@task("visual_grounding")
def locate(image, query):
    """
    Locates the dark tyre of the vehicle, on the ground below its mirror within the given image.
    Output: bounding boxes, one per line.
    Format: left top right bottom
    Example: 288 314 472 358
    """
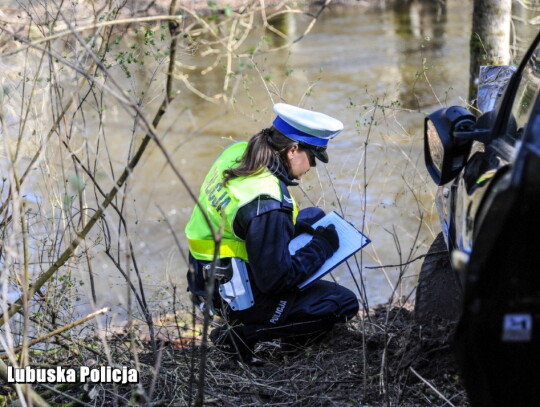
414 232 463 322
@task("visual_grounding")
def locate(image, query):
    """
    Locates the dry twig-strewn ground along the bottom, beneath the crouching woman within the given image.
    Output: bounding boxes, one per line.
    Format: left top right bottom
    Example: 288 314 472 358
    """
6 306 469 407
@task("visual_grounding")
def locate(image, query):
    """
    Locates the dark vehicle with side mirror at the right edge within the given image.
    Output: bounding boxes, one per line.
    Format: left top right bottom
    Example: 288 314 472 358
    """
417 34 540 407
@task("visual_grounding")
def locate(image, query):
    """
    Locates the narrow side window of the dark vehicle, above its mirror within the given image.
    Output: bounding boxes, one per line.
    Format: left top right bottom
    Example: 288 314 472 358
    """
504 46 540 144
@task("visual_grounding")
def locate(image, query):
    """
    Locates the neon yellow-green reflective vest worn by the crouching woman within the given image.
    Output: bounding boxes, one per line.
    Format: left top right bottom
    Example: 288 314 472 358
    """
185 142 298 261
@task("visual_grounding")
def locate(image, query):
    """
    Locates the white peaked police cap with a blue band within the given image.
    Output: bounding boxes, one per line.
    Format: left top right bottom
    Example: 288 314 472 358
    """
273 103 343 148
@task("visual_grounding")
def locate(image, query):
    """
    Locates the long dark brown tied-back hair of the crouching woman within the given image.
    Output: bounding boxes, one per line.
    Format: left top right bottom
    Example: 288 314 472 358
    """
223 126 298 185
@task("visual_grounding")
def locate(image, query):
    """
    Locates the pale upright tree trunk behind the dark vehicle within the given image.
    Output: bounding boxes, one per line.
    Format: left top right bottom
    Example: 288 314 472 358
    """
469 0 512 100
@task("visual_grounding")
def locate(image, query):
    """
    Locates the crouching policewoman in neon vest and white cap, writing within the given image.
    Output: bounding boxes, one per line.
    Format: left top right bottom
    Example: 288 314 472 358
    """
185 103 358 360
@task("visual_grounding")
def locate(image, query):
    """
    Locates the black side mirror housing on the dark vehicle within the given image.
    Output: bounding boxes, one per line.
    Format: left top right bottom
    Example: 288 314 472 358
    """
424 106 476 185
